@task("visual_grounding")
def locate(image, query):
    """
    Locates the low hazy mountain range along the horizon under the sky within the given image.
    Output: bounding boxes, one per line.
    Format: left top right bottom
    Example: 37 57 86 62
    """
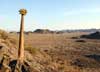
10 29 100 34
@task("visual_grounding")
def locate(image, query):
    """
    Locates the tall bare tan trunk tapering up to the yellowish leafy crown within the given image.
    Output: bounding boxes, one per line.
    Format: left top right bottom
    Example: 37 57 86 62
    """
14 14 24 72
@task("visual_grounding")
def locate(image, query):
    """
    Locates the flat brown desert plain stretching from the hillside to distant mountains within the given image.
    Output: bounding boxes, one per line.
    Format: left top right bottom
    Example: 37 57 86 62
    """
10 32 100 72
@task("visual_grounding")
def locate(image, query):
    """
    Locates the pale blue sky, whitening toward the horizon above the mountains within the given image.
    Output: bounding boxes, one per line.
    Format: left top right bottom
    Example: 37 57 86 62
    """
0 0 100 31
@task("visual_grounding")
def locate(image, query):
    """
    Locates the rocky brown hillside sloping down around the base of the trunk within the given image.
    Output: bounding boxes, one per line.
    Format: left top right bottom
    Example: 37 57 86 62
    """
0 30 50 72
